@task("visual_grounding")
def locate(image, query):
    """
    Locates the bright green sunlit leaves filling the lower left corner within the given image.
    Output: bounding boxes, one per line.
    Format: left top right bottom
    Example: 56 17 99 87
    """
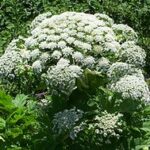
0 91 39 150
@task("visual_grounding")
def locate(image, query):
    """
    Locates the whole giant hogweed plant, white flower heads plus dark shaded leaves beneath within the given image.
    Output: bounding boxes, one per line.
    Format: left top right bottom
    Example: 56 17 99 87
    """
0 12 150 150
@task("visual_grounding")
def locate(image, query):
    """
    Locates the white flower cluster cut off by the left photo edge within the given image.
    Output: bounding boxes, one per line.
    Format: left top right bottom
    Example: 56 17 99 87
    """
0 51 22 78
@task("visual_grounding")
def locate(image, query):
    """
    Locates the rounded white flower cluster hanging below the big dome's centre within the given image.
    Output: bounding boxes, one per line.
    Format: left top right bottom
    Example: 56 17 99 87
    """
46 58 82 95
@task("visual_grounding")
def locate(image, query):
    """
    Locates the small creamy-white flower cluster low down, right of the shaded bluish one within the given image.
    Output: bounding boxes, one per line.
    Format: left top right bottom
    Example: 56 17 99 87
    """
88 112 123 139
